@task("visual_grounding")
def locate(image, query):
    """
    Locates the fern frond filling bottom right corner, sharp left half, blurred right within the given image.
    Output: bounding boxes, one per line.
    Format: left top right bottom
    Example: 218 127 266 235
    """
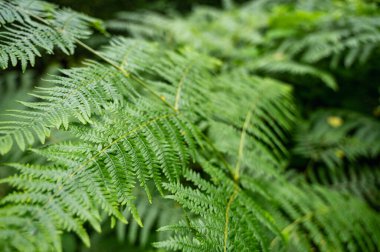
155 160 380 251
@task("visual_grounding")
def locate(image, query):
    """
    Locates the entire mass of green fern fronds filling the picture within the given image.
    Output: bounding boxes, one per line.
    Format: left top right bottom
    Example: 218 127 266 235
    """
0 0 380 251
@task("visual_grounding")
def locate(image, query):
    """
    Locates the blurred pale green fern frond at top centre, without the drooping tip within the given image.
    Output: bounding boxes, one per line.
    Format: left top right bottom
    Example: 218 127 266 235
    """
107 6 265 58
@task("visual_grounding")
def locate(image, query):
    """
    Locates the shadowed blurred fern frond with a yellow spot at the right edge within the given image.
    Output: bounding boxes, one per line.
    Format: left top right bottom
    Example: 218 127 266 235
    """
294 110 380 209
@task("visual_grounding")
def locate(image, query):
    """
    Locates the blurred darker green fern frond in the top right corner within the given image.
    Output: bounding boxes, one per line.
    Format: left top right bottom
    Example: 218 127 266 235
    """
275 2 379 68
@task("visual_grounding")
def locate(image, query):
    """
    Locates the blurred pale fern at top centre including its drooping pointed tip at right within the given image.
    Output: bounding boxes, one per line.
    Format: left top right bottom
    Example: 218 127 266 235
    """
108 4 337 89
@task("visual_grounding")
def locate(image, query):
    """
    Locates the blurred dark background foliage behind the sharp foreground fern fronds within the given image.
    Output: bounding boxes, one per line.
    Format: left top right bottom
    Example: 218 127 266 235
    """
0 0 380 252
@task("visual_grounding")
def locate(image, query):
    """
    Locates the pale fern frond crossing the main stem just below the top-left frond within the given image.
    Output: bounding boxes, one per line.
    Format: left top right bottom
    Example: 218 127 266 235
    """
0 38 217 154
